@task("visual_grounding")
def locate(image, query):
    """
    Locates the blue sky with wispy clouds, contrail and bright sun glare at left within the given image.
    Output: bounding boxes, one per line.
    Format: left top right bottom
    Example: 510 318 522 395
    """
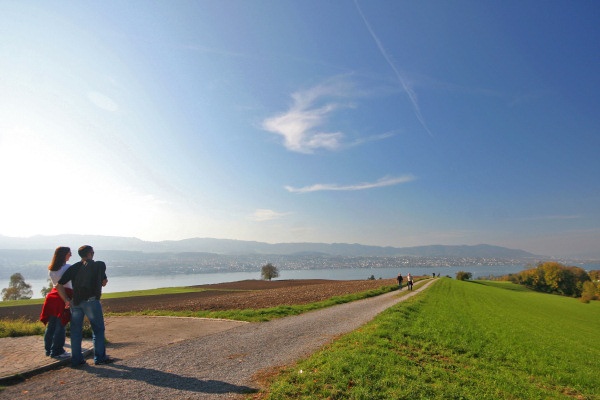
0 0 600 256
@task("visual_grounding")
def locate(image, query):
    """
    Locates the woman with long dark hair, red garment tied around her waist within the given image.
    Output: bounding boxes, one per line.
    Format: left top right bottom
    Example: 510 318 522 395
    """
40 246 73 360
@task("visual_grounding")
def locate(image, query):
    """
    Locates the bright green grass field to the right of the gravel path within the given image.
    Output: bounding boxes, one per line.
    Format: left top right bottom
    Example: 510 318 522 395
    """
264 279 600 399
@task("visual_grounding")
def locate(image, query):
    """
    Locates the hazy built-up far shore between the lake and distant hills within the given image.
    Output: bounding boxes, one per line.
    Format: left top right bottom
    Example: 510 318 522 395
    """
0 250 598 279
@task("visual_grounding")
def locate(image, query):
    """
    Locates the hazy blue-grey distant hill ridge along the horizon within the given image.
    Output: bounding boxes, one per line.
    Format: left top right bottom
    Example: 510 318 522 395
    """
0 235 536 258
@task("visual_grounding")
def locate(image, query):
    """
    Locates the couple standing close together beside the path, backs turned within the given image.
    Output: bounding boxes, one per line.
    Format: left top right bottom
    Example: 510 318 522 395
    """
40 245 114 367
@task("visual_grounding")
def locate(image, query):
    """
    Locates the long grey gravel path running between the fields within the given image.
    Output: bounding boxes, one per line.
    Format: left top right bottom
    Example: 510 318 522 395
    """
0 280 434 400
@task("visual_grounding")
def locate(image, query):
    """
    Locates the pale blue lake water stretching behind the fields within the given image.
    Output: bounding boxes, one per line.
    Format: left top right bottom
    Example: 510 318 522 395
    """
23 265 526 299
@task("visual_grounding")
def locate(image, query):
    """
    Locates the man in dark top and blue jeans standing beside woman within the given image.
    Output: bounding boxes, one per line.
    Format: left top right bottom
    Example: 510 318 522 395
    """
56 245 114 367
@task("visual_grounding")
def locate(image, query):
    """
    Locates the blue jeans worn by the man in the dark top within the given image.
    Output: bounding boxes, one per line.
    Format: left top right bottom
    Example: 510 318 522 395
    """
71 298 106 367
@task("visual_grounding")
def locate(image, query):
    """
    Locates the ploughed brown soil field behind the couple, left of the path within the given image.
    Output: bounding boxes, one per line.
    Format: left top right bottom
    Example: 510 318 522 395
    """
0 279 396 321
